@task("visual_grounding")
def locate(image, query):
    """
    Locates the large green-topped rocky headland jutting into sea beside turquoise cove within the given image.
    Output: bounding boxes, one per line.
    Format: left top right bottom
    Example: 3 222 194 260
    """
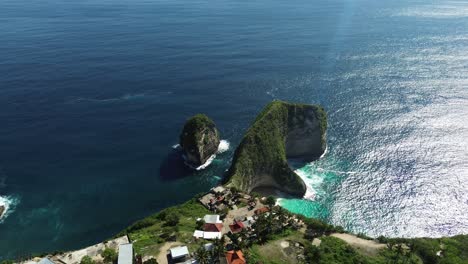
228 101 327 197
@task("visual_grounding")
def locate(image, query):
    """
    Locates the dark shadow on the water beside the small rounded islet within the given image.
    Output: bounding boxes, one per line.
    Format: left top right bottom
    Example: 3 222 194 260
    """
159 149 193 181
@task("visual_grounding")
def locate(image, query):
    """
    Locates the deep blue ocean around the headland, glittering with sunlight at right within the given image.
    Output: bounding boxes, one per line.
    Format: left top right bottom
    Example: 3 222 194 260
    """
0 0 468 259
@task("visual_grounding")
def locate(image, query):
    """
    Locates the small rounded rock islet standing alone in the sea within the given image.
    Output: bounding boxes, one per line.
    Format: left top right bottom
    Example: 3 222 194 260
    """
180 114 220 167
